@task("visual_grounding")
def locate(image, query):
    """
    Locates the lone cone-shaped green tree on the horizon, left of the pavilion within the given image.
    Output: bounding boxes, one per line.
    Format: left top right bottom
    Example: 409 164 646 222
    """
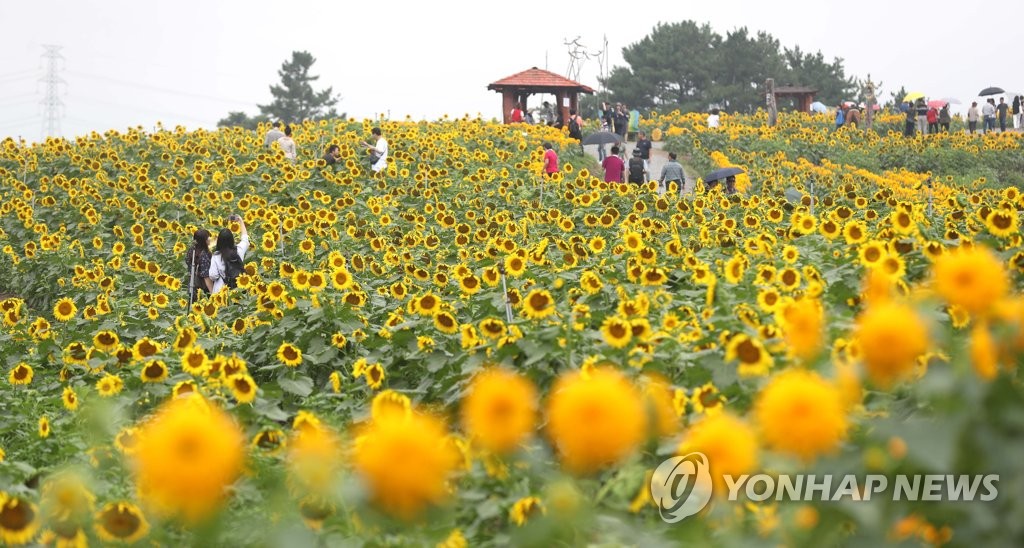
259 51 338 122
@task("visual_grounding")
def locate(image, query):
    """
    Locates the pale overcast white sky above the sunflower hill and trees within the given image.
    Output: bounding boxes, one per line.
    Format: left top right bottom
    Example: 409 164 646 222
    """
0 0 1024 140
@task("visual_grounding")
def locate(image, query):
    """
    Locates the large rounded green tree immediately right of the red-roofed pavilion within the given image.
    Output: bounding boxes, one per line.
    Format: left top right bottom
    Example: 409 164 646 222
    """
603 20 721 110
